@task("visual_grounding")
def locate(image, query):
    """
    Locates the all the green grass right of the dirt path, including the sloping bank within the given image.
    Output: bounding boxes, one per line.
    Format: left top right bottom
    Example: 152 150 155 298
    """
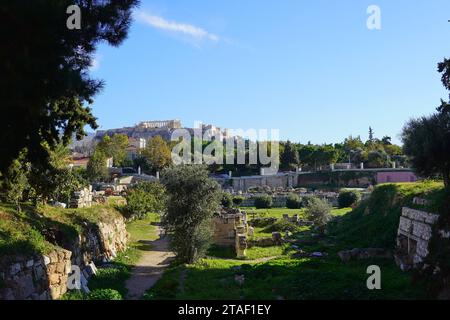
145 182 443 300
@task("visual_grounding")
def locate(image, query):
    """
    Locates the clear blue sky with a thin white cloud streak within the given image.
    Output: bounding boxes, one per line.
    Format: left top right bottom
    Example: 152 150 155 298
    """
91 0 450 143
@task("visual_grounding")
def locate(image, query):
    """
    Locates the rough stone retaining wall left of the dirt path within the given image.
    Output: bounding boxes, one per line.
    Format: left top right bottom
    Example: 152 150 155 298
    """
0 217 129 300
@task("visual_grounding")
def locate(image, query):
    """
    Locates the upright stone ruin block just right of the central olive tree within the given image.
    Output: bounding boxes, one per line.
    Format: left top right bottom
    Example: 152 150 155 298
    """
213 209 253 258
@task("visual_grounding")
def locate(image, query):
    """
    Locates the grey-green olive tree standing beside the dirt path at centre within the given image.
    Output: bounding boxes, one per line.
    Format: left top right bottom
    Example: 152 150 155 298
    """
162 165 222 263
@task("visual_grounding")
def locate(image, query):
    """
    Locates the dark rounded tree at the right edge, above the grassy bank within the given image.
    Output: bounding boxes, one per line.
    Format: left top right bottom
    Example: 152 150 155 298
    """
401 111 450 187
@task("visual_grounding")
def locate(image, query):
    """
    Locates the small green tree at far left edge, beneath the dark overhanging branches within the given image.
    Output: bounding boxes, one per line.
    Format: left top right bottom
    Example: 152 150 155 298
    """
2 151 29 212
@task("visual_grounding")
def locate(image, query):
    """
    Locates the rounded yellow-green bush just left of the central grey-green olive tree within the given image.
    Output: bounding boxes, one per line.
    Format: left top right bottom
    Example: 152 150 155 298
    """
125 181 166 219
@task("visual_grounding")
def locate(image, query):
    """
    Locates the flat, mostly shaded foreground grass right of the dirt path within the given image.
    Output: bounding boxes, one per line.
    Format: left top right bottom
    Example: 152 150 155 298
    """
145 250 424 300
